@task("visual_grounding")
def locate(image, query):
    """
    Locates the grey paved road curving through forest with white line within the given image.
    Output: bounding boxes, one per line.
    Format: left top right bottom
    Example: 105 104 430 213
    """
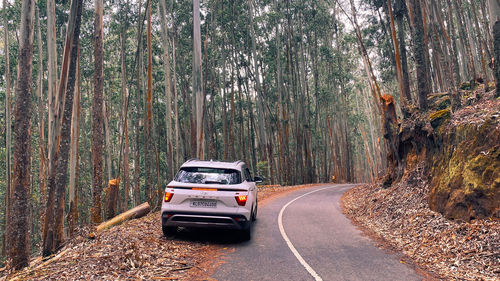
212 185 422 280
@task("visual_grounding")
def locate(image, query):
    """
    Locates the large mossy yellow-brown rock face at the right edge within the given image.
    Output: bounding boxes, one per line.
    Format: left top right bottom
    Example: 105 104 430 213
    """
429 121 500 221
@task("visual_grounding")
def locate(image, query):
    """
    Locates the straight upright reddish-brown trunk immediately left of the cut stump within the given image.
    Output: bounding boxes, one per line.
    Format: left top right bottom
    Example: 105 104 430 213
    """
91 0 104 223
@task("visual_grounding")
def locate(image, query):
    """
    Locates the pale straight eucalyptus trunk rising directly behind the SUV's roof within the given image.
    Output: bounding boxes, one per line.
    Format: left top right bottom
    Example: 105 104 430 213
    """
193 0 205 159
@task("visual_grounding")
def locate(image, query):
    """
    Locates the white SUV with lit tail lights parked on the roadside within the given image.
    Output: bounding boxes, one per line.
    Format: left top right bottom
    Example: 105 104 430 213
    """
161 159 262 240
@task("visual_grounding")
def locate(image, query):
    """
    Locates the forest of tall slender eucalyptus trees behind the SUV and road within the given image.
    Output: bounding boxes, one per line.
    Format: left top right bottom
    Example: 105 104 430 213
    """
0 0 500 268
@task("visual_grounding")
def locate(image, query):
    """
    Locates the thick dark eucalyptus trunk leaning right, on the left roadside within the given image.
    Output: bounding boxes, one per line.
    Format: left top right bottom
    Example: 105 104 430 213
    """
42 0 83 256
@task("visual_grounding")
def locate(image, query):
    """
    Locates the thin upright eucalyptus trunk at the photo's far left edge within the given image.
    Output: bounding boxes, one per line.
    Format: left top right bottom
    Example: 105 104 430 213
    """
2 0 12 258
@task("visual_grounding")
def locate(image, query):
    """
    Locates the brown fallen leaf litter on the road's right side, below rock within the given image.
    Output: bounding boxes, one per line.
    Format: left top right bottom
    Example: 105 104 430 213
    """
342 162 500 280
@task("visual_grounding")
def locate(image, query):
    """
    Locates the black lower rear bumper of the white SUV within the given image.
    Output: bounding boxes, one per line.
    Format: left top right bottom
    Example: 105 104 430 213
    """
161 211 250 230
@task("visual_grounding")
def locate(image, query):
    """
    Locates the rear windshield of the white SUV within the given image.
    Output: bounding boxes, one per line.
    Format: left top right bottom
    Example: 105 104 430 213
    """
175 167 241 184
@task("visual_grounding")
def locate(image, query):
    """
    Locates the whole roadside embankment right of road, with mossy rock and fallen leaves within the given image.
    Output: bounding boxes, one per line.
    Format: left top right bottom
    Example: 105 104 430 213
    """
343 85 500 280
